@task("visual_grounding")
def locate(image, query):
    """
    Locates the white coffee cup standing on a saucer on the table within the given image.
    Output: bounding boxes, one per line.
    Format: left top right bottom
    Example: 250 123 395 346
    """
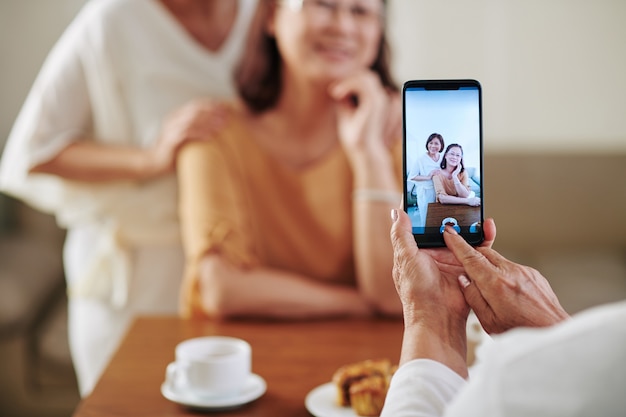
166 336 252 397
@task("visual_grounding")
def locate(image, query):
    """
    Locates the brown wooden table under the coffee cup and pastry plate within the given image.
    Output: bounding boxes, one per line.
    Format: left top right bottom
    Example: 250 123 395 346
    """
74 317 403 417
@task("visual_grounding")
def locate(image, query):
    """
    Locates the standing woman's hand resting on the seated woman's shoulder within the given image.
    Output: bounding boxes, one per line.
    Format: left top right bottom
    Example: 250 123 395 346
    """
151 100 227 173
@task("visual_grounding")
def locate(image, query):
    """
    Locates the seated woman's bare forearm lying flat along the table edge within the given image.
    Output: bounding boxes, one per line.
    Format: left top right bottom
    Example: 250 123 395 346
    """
199 254 373 320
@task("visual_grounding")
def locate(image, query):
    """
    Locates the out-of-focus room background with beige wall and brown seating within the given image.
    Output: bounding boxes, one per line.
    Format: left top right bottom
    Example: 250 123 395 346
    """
0 0 626 417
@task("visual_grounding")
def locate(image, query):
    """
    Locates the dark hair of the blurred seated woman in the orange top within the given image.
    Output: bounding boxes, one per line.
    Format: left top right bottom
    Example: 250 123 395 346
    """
235 0 398 113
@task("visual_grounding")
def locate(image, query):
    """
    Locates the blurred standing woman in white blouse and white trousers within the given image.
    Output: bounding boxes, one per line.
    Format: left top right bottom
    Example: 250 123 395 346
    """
0 0 256 395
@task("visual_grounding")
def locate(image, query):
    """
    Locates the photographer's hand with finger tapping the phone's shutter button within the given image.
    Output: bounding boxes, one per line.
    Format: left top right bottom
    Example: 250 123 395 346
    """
444 227 569 333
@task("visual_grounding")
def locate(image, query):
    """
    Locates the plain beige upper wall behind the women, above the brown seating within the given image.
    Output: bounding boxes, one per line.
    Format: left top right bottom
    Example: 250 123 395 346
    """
0 0 626 153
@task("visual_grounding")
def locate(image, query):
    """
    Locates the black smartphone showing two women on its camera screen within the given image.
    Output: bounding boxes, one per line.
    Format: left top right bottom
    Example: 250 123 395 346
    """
402 80 484 247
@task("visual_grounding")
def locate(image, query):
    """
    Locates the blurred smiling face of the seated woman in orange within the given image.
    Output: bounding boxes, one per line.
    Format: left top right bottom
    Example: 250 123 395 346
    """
268 0 383 83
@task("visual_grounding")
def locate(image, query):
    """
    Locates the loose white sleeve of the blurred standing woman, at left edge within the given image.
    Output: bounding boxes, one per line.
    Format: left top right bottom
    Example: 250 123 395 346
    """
0 6 92 212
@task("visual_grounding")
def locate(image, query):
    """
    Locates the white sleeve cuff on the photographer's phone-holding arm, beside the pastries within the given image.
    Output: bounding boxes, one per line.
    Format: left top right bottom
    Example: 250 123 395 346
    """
380 359 466 417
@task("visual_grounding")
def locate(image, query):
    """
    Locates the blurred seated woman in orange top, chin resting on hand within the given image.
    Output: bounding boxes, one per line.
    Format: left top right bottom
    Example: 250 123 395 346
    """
177 0 402 319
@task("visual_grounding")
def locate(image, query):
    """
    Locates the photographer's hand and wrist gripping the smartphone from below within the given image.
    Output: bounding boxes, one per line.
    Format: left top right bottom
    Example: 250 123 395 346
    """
391 210 495 378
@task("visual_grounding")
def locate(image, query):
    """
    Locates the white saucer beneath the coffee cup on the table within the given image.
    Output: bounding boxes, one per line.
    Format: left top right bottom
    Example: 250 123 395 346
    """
161 374 267 411
